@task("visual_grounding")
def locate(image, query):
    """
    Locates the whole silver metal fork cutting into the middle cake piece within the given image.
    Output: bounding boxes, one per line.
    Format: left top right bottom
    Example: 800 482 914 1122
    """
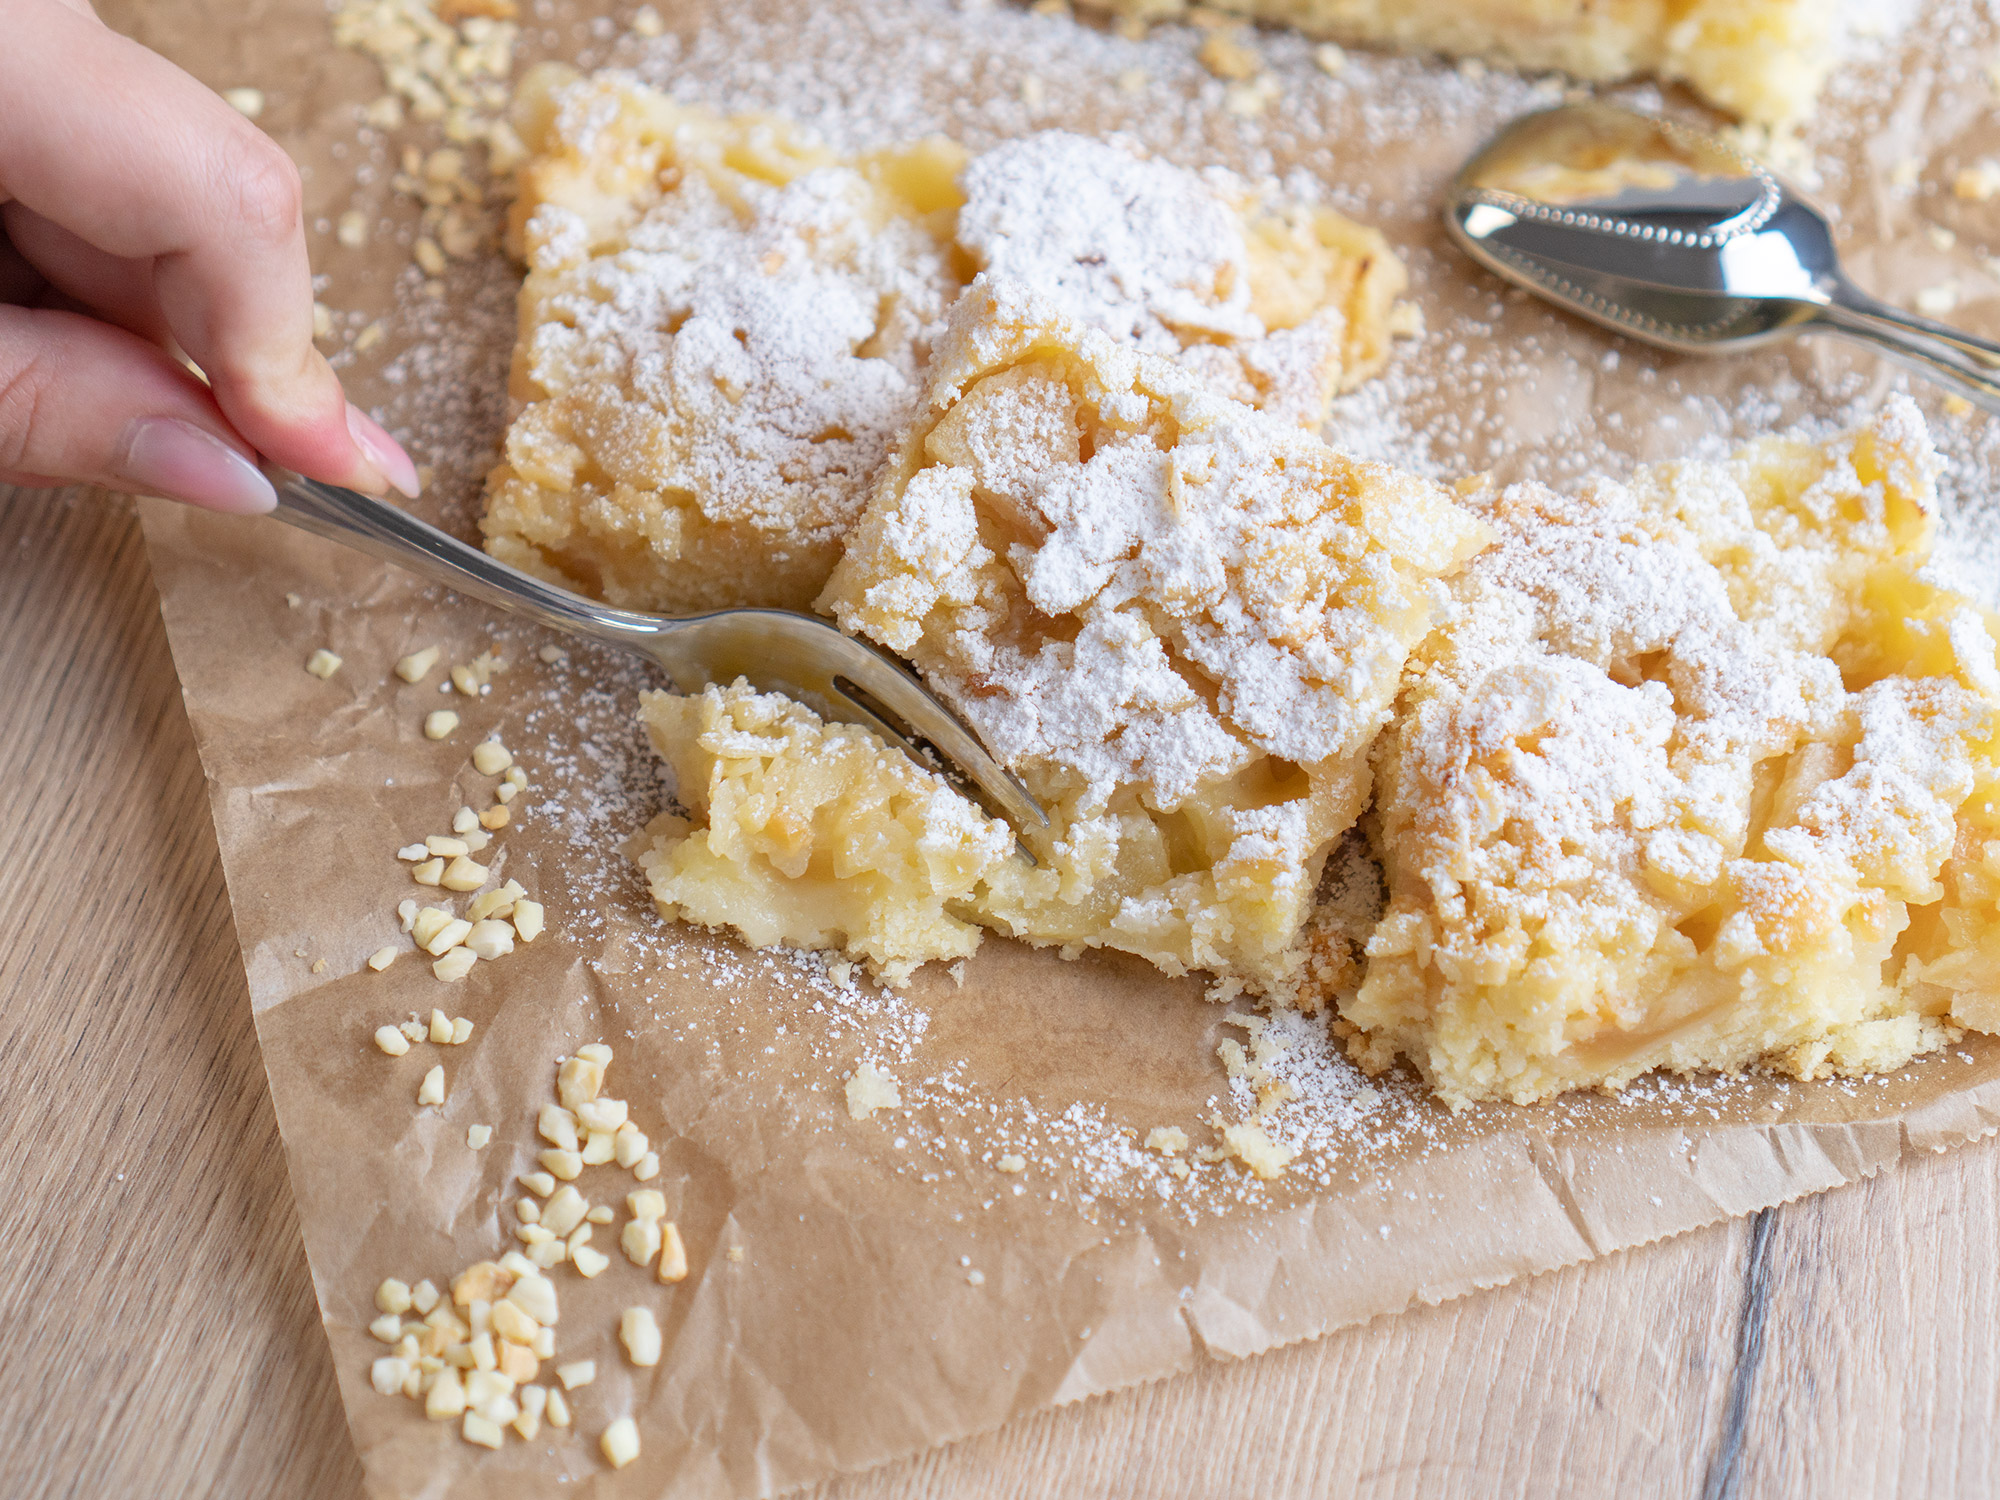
266 468 1048 860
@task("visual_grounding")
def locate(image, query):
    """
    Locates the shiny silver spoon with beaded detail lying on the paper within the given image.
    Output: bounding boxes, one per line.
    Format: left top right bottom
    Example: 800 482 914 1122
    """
1444 102 2000 412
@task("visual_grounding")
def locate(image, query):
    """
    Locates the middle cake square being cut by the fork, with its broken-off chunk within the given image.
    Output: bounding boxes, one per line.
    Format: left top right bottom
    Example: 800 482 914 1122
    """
650 278 1484 990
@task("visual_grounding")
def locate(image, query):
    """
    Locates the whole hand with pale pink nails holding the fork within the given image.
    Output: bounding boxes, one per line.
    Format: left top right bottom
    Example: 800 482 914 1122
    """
0 0 416 514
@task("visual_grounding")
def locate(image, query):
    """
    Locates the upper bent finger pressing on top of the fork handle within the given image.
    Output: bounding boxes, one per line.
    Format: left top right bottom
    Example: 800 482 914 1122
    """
0 0 416 492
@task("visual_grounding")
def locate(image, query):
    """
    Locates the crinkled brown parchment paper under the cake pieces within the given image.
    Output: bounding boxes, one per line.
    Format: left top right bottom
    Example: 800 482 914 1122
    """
112 0 2000 1496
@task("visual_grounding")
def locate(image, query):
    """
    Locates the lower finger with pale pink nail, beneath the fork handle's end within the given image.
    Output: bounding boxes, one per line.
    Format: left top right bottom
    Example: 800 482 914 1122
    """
0 306 278 514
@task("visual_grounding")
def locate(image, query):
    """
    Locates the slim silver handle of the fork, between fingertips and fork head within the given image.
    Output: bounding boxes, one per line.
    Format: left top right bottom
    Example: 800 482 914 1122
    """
266 468 666 650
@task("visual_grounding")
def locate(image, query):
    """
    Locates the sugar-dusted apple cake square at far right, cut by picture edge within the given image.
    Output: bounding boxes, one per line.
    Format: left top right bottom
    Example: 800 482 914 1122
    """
1342 398 2000 1106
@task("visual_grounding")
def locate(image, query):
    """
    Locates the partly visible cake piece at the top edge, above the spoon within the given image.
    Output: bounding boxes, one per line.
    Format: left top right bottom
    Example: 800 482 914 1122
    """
1086 0 1864 126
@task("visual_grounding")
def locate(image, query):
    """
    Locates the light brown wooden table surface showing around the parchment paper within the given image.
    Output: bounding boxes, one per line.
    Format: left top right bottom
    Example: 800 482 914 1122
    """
0 488 2000 1500
